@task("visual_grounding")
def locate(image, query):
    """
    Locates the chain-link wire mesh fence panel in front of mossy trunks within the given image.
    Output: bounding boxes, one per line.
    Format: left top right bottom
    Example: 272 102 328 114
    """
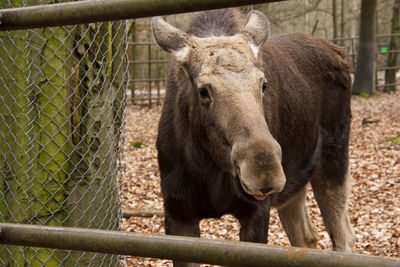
0 0 128 266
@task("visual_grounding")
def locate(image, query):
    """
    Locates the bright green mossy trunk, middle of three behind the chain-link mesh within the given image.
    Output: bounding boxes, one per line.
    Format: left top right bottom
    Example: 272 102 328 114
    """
28 22 73 266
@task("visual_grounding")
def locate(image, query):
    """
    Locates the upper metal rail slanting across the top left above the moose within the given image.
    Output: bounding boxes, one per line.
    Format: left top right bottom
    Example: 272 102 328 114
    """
0 0 285 31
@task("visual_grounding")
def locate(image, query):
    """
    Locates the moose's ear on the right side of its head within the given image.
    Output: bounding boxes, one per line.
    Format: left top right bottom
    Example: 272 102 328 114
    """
241 10 269 57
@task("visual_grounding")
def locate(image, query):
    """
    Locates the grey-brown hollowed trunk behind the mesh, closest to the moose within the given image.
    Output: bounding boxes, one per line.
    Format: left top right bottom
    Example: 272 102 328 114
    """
65 22 123 266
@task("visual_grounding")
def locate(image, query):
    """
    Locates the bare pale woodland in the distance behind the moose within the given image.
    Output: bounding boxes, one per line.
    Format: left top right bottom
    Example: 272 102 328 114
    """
129 0 400 106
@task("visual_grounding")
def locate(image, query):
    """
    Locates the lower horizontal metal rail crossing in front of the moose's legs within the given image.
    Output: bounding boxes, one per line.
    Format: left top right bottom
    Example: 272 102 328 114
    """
0 224 400 267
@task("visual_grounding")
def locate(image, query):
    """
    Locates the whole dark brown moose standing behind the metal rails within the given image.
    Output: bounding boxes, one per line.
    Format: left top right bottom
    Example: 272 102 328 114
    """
153 9 354 264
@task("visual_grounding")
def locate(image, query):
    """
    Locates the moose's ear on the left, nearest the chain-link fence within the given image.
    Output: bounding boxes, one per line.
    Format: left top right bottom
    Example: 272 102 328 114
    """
151 17 189 62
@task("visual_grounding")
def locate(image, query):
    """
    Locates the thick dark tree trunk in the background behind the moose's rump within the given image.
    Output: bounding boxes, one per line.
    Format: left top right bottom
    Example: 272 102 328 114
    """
353 0 377 96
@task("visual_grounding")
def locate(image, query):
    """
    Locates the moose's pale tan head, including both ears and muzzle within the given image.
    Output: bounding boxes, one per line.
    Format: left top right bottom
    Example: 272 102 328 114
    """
152 11 286 198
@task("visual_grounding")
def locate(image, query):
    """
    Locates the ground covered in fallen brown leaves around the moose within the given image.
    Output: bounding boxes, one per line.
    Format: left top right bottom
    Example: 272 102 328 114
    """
123 91 400 266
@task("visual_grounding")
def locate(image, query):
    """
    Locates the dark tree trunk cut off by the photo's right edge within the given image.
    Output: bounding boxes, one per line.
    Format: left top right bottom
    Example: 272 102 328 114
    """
384 0 400 93
